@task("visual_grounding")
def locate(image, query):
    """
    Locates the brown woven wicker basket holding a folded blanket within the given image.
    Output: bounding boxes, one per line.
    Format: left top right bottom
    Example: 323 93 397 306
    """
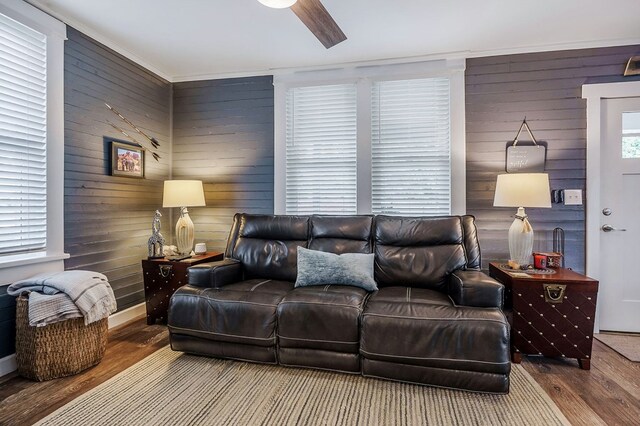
16 295 108 381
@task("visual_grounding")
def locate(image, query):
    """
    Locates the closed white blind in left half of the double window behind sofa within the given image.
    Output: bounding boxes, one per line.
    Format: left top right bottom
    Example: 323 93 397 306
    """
285 84 357 214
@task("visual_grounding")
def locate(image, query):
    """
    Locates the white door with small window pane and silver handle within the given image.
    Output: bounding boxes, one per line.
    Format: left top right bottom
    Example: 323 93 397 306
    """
598 98 640 332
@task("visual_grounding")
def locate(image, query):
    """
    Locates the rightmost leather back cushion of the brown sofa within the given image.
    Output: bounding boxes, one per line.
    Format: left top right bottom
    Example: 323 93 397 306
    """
374 215 467 292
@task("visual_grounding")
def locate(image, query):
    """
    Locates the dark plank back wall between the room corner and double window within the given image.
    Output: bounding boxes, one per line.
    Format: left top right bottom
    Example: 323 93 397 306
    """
171 76 273 250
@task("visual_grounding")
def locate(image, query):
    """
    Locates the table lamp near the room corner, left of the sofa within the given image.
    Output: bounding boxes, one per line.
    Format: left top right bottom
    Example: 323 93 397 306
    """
162 180 206 255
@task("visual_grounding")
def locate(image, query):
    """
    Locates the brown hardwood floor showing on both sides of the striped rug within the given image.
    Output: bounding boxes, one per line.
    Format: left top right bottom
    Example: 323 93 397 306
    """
0 319 640 426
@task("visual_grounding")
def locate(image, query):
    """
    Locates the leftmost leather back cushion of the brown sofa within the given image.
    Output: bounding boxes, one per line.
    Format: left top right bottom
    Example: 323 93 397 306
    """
227 213 309 281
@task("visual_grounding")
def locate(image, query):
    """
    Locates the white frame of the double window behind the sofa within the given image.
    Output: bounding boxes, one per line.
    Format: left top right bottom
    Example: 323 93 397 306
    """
273 59 466 215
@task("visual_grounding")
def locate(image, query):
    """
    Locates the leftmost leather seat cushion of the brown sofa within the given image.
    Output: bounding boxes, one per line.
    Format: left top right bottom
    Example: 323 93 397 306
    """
168 279 293 346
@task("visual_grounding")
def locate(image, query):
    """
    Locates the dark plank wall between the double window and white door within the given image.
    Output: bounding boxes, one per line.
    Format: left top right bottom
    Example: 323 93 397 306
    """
466 46 640 272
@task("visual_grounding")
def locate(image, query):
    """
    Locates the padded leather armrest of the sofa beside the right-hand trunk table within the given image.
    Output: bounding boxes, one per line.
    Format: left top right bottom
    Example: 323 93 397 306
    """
449 269 504 309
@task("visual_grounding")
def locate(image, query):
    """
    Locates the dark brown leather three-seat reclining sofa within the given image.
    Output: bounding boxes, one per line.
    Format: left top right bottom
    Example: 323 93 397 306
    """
168 214 511 393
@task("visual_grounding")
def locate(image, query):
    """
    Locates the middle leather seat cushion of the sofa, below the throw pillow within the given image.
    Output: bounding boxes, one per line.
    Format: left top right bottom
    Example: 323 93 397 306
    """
278 285 368 354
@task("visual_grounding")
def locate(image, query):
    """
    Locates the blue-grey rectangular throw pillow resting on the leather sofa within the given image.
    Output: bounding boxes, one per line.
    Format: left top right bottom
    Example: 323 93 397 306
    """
296 247 378 291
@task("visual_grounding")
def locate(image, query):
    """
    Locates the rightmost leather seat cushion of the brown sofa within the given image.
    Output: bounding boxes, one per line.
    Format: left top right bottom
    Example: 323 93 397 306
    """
360 287 510 374
